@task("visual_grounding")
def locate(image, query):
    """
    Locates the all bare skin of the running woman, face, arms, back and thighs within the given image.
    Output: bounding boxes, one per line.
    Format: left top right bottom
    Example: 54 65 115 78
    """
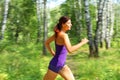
43 20 88 80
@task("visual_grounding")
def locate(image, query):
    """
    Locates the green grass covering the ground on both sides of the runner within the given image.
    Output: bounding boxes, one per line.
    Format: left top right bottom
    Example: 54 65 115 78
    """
0 43 120 80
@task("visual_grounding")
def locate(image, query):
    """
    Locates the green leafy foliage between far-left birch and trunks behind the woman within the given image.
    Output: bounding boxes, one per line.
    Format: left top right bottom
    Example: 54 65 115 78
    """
6 0 38 41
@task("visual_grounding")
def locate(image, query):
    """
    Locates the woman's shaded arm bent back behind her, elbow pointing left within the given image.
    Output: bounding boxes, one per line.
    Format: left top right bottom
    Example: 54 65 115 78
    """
45 35 55 56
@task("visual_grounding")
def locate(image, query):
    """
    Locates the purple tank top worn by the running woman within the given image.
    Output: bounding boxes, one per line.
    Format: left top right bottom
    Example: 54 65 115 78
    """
50 43 67 67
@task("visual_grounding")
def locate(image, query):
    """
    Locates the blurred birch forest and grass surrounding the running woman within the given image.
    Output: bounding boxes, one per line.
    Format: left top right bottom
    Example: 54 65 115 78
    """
0 0 120 80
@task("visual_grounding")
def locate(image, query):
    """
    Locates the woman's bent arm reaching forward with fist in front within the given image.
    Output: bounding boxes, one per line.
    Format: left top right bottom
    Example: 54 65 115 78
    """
63 34 88 53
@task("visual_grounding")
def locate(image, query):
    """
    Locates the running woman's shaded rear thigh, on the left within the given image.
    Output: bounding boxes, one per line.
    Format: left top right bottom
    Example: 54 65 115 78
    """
43 69 57 80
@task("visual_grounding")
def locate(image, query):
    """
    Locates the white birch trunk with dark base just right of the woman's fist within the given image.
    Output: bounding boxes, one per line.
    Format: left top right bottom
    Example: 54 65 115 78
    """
84 0 94 57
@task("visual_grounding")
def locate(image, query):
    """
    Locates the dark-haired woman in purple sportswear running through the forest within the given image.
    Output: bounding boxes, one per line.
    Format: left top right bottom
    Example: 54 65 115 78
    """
44 16 88 80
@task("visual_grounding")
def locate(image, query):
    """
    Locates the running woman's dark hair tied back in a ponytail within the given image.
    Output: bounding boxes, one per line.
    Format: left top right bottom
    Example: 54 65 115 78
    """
54 16 70 37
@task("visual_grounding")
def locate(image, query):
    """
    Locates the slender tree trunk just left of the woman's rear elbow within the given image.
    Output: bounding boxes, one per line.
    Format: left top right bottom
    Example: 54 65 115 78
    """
43 0 47 55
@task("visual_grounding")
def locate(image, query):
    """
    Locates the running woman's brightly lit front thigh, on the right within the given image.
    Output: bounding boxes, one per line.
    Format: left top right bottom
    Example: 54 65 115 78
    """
59 65 75 80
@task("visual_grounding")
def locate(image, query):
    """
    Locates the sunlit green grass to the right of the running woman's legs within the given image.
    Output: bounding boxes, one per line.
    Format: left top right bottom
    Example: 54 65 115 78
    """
68 49 120 80
